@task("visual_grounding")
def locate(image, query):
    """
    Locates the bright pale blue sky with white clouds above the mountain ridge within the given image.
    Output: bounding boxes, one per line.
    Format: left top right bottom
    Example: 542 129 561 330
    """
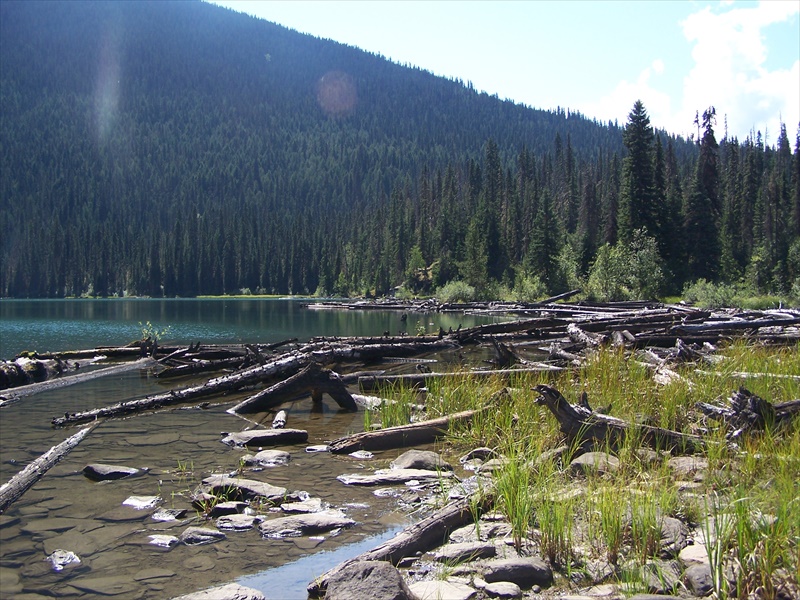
215 0 800 145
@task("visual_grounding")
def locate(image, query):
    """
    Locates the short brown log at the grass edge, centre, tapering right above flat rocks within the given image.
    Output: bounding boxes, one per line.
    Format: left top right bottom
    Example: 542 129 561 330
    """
328 408 486 454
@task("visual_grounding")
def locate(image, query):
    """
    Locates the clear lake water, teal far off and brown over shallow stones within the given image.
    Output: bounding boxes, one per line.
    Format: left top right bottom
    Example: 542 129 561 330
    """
0 300 500 599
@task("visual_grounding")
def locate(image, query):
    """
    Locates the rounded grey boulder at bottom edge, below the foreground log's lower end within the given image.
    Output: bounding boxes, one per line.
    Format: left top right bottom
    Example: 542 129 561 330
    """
325 560 416 600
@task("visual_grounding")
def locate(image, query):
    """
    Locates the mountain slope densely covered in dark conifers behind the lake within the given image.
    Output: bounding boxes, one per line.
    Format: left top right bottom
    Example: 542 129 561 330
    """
0 0 798 297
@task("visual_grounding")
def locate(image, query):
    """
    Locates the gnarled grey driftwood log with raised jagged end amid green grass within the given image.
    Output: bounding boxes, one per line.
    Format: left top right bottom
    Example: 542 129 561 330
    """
533 385 705 453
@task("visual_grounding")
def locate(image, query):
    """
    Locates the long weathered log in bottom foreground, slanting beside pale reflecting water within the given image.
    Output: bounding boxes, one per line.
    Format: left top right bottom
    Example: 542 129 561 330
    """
306 493 494 598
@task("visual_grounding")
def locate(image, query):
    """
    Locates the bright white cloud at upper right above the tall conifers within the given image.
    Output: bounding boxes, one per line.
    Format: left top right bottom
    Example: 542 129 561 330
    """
672 1 800 142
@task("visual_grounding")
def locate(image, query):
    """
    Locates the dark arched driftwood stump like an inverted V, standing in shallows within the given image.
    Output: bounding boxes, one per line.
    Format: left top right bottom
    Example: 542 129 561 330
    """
229 362 358 414
